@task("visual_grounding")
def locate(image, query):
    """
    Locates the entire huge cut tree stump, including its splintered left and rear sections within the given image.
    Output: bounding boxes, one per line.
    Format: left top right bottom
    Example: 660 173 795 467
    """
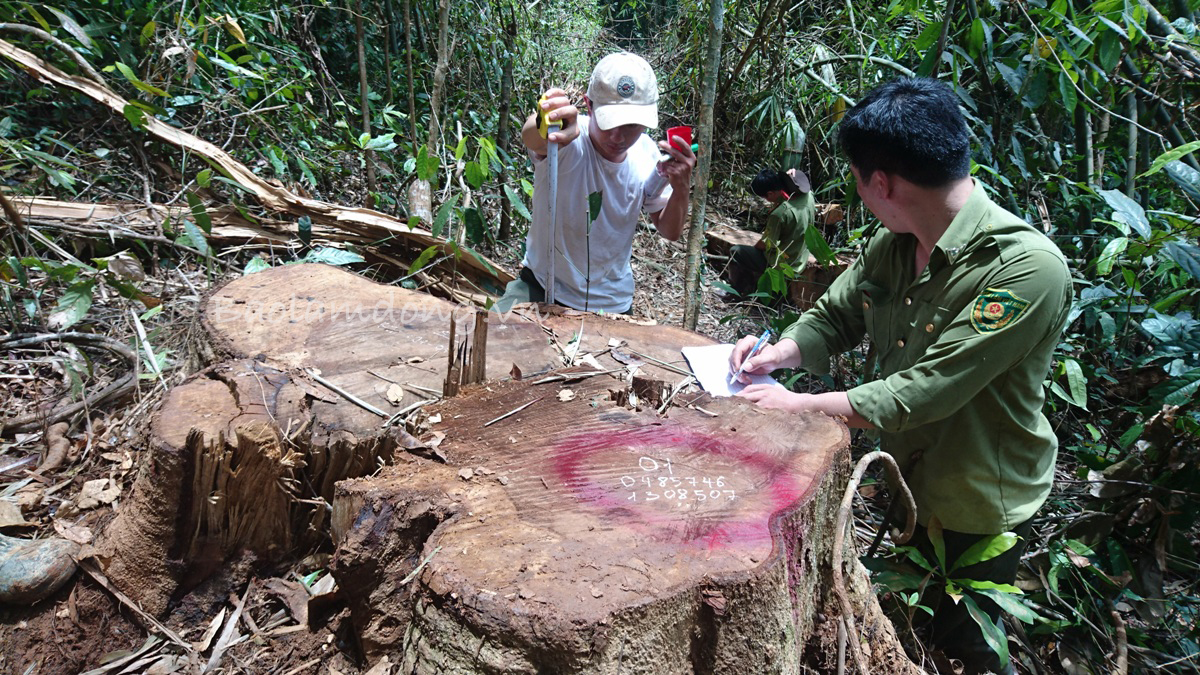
85 265 907 673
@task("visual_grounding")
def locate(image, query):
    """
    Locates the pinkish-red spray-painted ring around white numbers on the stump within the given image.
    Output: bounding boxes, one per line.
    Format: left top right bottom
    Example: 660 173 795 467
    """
551 425 804 550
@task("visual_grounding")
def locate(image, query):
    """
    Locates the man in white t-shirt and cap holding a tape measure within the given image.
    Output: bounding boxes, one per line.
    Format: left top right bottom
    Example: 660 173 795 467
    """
496 52 696 313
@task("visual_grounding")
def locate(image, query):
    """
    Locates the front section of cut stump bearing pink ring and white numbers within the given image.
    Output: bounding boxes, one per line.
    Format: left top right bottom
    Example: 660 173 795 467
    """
334 378 848 673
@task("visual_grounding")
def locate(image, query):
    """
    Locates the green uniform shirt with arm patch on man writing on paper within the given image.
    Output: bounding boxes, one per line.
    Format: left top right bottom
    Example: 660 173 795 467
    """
782 184 1072 534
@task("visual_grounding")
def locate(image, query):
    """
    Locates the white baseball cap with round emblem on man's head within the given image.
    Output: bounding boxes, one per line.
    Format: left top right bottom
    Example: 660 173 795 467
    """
588 52 659 131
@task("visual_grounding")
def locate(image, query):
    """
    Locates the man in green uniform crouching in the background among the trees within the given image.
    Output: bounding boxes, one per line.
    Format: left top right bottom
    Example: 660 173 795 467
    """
730 168 816 297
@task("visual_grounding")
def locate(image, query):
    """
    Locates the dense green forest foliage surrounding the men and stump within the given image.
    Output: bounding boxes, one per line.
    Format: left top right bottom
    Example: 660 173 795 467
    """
0 0 1200 671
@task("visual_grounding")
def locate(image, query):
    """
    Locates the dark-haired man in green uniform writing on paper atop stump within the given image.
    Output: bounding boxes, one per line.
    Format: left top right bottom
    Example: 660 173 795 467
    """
730 79 1072 673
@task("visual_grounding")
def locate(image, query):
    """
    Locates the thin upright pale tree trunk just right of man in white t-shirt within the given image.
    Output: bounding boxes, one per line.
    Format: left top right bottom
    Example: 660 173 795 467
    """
683 0 725 330
